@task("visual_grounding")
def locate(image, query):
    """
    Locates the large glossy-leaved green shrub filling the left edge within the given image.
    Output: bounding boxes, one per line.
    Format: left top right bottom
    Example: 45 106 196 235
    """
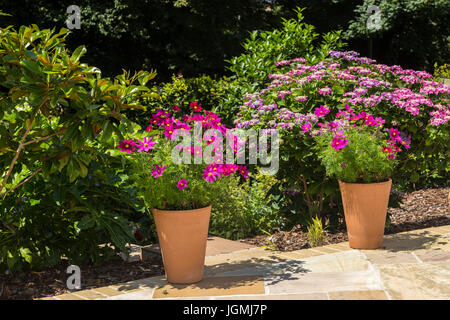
0 25 154 271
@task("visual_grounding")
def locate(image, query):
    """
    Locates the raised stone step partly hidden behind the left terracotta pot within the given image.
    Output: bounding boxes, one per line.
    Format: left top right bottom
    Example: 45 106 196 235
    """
141 236 256 261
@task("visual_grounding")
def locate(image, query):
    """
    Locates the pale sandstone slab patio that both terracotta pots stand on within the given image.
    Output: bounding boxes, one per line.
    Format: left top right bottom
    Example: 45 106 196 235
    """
43 226 450 300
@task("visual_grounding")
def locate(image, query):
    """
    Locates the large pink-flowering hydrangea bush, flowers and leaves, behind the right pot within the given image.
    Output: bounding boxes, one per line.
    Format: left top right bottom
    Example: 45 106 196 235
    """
235 51 450 219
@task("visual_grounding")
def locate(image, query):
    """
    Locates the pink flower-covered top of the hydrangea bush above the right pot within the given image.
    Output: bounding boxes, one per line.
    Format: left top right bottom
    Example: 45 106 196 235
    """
234 51 450 144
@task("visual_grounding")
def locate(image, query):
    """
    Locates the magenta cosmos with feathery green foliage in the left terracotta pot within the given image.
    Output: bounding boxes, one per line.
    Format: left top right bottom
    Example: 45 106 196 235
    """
117 102 249 210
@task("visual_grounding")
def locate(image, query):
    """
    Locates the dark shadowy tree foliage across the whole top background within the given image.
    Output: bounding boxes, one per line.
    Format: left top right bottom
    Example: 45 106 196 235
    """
0 0 450 81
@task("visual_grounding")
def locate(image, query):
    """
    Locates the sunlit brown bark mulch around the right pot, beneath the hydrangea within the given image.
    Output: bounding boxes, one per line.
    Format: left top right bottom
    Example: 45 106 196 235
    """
239 188 450 251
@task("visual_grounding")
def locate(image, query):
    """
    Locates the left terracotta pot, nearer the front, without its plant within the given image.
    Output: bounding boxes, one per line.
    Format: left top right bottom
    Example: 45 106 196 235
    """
152 206 211 284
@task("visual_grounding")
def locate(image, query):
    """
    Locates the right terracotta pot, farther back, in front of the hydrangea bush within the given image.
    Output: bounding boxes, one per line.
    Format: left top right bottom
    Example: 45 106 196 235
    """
339 179 392 249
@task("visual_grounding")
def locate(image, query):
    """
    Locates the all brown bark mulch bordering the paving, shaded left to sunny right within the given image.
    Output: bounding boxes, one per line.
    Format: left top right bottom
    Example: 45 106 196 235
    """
0 188 450 299
